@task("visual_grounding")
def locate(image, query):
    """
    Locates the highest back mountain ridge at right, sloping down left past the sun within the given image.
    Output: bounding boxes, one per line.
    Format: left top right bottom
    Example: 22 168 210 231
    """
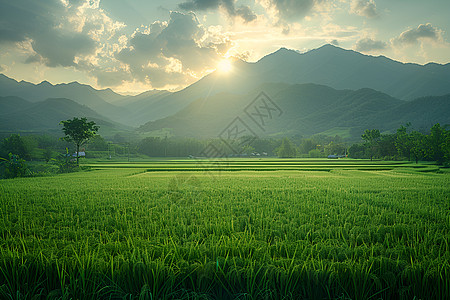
124 45 450 121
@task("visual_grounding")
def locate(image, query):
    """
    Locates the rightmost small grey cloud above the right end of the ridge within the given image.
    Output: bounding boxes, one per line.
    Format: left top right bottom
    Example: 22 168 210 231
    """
391 23 443 46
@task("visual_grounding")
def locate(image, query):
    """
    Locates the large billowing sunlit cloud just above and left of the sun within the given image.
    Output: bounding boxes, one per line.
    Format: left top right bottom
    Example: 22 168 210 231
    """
115 12 231 88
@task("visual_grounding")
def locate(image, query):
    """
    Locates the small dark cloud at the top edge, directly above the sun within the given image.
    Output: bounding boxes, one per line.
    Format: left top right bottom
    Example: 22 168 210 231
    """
178 0 257 23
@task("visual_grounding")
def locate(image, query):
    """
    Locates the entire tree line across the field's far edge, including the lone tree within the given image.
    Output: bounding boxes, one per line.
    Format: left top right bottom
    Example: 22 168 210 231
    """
0 118 450 177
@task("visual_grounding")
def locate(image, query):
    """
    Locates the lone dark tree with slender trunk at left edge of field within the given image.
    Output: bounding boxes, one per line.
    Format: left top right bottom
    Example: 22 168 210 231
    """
59 118 99 166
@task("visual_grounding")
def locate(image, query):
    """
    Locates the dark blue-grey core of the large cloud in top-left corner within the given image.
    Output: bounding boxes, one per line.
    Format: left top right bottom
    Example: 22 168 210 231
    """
0 0 96 67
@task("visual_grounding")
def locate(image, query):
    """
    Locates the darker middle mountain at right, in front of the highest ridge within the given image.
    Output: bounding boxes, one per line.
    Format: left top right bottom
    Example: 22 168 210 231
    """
139 83 450 139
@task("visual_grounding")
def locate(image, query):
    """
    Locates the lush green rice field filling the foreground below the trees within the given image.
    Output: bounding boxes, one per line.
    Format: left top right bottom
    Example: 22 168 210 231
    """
0 159 450 300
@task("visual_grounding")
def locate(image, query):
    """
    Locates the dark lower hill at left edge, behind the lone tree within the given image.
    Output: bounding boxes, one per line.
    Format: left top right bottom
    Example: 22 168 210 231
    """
0 97 129 134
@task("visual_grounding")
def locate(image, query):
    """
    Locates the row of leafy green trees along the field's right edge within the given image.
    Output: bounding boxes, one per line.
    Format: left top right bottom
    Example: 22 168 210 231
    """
277 123 450 165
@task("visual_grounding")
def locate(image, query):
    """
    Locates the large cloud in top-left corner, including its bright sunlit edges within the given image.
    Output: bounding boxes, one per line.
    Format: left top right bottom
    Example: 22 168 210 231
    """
0 0 123 67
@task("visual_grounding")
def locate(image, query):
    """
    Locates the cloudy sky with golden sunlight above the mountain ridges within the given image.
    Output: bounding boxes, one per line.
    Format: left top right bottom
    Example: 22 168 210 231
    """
0 0 450 94
